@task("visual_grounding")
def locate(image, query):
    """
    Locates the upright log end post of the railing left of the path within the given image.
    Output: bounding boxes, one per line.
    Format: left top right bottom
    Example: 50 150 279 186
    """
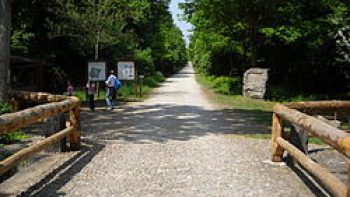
70 104 80 150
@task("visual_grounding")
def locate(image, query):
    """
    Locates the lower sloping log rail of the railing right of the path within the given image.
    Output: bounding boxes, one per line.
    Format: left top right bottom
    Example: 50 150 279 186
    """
277 137 347 197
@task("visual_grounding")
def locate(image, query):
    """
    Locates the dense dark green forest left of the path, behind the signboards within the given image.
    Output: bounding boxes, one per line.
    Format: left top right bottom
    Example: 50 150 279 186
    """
11 0 187 92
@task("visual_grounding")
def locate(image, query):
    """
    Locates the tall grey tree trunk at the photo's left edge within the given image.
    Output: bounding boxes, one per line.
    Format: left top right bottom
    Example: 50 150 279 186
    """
0 0 12 102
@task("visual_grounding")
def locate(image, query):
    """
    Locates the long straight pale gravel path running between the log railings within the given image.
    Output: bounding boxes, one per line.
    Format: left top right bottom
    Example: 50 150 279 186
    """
23 66 317 197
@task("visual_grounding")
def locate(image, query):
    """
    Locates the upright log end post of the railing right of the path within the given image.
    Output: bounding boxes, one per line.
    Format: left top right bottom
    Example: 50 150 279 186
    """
272 113 284 162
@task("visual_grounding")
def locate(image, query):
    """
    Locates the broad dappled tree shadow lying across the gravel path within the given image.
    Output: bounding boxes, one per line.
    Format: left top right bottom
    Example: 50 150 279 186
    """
82 104 270 143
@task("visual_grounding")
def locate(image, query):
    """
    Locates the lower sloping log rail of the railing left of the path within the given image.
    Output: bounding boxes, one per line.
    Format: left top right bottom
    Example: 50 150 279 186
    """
0 127 74 174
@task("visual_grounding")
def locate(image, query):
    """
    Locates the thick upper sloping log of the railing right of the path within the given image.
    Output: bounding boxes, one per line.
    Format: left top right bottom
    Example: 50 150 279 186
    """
273 104 350 158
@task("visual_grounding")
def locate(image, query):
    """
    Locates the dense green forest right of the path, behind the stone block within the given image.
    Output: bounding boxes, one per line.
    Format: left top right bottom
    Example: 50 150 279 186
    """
181 0 350 97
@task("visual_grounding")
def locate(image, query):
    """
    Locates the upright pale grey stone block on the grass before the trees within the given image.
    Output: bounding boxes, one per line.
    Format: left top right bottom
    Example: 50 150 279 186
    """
242 68 269 99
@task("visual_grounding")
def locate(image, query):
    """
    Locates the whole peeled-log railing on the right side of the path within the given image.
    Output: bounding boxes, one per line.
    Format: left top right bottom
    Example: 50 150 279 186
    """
272 101 350 196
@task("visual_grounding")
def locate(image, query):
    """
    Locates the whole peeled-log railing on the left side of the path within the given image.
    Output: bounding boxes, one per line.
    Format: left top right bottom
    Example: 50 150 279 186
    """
0 91 80 175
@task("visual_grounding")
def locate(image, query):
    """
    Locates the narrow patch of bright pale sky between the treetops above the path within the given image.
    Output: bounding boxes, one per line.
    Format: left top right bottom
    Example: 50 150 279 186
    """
169 0 192 45
